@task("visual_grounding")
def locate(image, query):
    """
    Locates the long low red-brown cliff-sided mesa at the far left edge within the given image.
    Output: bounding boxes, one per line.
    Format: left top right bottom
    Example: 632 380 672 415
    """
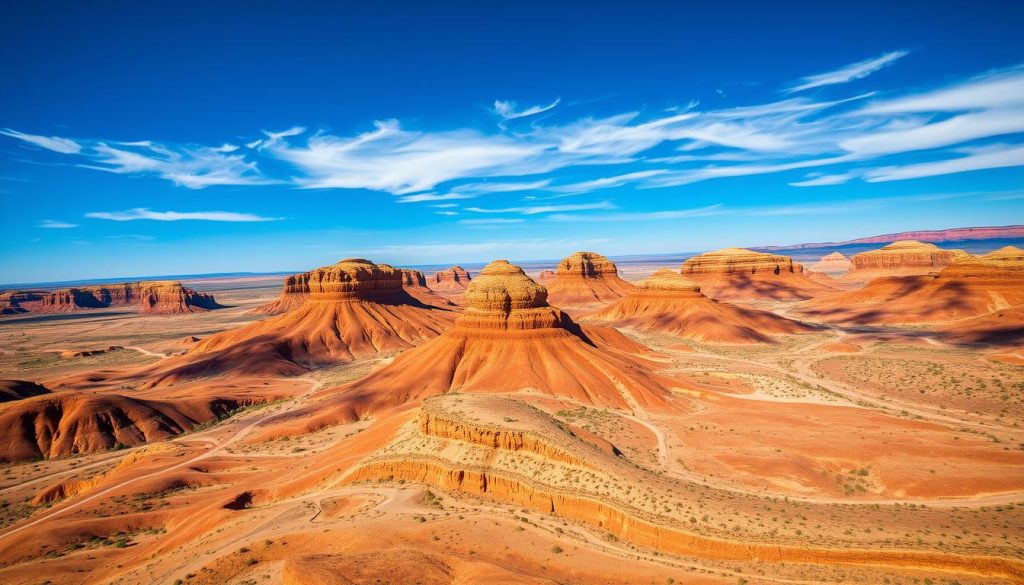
0 281 221 315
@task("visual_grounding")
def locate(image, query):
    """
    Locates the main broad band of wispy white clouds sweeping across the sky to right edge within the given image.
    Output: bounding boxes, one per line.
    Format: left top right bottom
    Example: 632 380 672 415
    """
3 60 1024 196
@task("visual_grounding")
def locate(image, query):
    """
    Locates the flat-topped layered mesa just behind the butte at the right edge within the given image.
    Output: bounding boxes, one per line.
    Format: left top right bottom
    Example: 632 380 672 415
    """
843 240 971 283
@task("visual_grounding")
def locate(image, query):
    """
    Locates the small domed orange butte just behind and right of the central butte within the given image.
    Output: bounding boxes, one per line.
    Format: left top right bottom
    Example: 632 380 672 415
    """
548 252 633 308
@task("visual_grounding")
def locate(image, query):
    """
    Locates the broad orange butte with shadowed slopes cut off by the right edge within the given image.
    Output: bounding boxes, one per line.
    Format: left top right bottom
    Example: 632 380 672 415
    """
800 245 1024 335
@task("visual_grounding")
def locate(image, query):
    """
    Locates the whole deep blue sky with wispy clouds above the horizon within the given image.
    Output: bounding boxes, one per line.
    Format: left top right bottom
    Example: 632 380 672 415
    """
0 2 1024 283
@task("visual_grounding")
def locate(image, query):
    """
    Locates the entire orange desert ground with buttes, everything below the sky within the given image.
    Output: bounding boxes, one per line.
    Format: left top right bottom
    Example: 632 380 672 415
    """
0 241 1024 585
